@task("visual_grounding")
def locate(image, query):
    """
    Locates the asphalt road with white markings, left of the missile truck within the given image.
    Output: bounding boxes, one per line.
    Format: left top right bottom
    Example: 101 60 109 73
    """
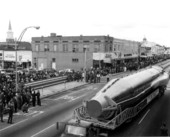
0 84 104 137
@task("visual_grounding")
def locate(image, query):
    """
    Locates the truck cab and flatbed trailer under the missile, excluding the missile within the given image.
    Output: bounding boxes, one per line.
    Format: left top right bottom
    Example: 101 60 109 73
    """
57 88 164 137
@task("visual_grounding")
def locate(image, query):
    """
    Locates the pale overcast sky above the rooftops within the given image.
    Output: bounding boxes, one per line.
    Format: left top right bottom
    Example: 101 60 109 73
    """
0 0 170 47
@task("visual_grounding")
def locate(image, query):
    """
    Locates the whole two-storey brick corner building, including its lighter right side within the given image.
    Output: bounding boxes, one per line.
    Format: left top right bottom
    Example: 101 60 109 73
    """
32 33 139 70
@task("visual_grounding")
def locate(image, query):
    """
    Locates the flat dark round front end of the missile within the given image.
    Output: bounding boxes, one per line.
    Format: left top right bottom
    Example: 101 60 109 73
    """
87 100 102 118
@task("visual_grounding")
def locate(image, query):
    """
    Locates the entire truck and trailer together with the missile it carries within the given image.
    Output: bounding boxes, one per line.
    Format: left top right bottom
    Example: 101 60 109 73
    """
57 66 169 137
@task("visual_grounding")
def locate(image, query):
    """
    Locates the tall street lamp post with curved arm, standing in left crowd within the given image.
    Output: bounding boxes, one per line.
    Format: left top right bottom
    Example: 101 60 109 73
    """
15 26 40 92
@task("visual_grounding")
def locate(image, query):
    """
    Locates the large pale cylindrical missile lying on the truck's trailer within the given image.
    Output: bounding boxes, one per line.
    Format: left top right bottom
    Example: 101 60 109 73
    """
86 66 169 120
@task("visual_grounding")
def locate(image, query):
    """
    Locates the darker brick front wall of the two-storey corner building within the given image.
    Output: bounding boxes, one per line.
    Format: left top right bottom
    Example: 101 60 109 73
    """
32 33 113 70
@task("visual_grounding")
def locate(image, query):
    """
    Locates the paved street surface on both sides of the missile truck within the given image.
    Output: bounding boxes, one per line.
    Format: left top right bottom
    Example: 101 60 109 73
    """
0 66 170 137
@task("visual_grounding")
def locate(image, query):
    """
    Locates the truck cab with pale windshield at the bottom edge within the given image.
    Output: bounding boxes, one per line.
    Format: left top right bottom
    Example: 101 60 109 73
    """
57 119 105 137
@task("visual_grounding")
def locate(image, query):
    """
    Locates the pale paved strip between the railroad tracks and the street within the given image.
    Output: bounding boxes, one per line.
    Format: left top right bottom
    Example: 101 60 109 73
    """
39 81 88 98
